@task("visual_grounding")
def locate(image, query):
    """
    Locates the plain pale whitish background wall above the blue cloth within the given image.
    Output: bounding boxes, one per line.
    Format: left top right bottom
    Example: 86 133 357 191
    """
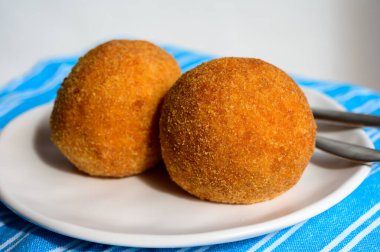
0 0 380 90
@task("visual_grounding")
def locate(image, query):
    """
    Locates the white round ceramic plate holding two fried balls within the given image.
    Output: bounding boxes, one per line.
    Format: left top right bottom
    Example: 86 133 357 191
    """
0 90 373 247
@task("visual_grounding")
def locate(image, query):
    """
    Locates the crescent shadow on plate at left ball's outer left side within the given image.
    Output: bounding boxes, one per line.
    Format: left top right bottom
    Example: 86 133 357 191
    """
34 115 81 174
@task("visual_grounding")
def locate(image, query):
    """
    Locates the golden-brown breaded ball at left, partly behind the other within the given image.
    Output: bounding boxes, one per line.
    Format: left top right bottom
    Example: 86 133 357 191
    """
50 40 180 177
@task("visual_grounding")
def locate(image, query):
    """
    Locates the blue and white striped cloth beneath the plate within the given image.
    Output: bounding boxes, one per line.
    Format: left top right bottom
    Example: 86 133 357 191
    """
0 44 380 251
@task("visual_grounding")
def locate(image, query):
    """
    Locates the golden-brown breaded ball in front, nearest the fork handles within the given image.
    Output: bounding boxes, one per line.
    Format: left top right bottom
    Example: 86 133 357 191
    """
160 58 316 204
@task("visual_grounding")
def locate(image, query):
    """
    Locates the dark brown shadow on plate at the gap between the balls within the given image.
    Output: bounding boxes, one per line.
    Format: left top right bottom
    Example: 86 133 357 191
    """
137 162 199 201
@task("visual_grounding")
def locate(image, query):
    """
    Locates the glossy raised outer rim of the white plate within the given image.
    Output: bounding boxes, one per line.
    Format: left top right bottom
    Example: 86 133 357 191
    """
0 87 374 248
